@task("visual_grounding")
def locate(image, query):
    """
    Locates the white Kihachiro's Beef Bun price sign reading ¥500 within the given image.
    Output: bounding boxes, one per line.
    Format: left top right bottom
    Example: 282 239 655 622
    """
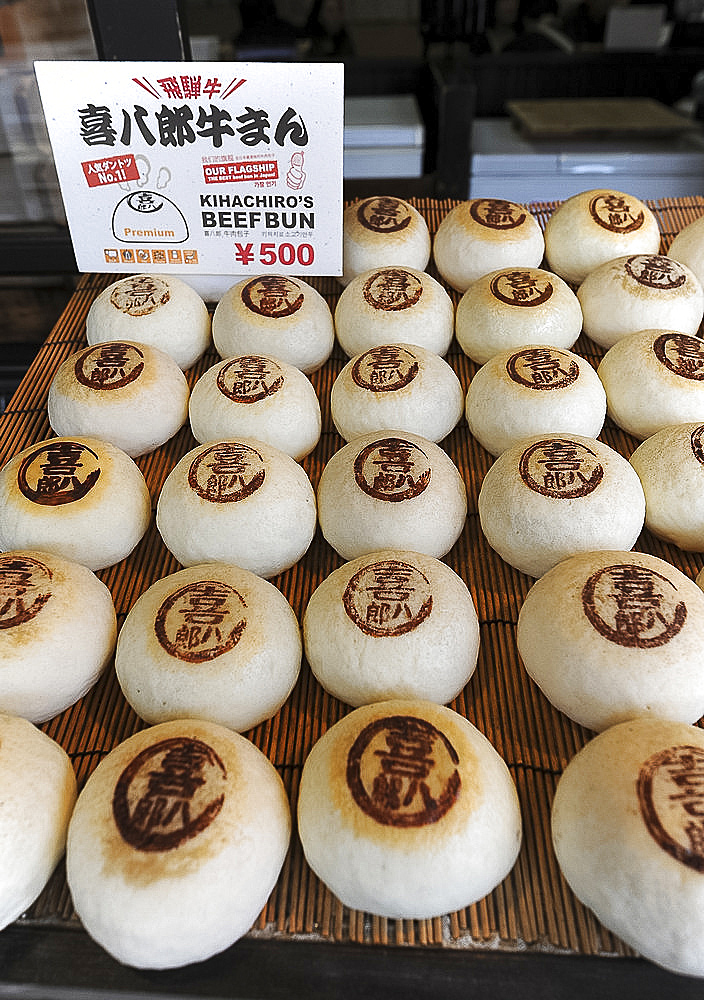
35 61 344 284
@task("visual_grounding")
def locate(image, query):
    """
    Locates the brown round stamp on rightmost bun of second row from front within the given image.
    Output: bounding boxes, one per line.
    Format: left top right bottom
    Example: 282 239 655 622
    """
582 563 687 649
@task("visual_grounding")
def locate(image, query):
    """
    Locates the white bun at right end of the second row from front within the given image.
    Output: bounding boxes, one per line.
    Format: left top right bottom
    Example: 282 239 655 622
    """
517 549 704 731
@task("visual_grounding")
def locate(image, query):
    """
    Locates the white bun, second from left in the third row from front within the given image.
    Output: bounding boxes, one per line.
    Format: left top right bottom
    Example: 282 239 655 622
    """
156 438 316 577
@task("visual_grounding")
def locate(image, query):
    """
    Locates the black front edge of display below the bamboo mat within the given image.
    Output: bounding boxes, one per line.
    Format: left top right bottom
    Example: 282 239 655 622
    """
0 925 704 1000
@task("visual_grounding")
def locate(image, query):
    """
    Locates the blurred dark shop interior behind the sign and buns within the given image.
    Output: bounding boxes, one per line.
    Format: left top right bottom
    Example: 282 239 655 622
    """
0 0 704 402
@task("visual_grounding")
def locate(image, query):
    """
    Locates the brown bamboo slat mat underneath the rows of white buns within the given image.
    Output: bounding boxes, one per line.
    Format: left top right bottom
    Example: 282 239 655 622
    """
0 197 704 956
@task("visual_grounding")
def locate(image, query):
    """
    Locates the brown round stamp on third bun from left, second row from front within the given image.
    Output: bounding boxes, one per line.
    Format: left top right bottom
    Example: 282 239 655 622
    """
342 559 433 638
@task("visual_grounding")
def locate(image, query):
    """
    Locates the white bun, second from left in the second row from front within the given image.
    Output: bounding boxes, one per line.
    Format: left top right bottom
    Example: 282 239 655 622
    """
115 563 300 732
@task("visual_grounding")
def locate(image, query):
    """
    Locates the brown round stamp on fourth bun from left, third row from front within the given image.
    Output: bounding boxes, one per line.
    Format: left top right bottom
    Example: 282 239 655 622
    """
519 438 604 500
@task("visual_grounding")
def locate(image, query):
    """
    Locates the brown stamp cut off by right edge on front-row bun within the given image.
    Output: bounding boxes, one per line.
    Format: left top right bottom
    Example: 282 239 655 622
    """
637 746 704 873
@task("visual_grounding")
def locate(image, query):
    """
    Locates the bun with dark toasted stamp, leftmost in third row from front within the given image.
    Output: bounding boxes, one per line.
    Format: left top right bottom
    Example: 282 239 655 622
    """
0 437 152 571
